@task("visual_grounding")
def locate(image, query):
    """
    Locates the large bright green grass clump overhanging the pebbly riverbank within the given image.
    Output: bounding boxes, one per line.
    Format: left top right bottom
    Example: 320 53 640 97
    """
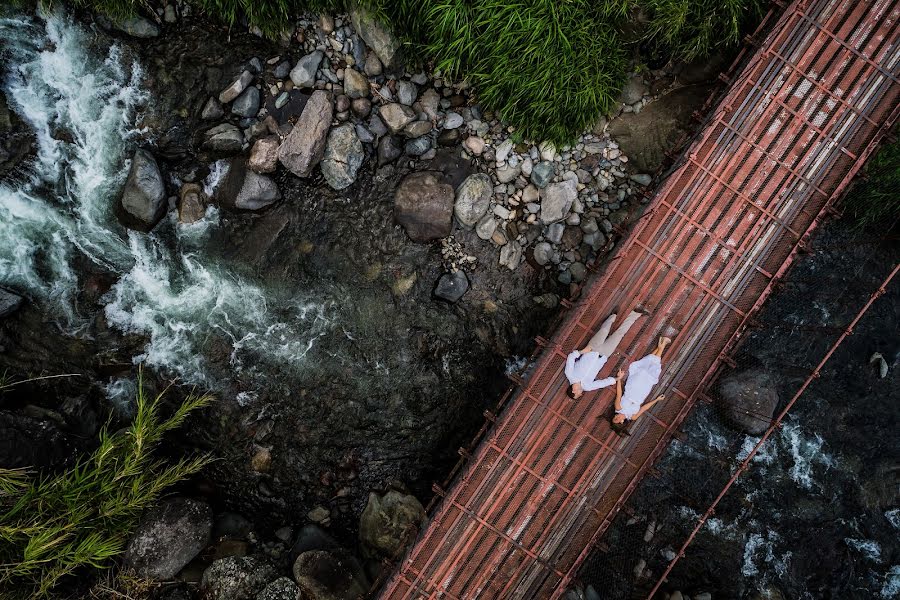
370 0 626 143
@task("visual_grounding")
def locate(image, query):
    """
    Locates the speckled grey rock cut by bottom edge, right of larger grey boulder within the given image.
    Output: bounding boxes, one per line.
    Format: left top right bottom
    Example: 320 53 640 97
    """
200 556 278 600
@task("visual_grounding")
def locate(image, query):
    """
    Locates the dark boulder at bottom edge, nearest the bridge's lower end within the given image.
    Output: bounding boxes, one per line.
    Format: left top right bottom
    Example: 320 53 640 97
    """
294 550 369 600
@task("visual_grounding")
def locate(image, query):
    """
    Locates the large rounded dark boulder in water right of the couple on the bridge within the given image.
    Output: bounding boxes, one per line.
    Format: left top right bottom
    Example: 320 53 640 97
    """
719 366 778 435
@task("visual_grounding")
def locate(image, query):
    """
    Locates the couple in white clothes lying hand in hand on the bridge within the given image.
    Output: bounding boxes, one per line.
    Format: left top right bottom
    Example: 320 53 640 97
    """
566 311 672 425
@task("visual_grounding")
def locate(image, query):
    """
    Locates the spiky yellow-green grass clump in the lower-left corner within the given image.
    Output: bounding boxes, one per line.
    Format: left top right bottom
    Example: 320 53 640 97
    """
0 382 210 598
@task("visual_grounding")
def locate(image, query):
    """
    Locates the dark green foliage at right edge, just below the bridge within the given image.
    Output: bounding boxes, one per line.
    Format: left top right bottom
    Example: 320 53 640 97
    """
844 142 900 228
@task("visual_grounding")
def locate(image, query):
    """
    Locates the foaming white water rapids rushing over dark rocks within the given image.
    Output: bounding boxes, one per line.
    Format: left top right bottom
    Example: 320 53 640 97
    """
0 13 331 394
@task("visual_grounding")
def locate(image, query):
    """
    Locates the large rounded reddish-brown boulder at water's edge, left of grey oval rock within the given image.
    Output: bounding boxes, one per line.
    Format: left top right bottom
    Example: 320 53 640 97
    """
394 171 455 242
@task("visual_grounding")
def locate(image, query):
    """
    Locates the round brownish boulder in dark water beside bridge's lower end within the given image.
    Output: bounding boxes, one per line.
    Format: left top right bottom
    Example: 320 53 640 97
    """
359 490 426 558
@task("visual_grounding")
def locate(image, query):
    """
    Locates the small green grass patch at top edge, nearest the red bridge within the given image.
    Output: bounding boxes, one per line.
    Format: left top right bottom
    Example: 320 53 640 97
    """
642 0 763 61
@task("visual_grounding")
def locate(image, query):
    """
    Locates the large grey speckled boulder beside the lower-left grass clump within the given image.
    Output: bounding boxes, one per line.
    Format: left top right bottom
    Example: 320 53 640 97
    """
123 498 212 580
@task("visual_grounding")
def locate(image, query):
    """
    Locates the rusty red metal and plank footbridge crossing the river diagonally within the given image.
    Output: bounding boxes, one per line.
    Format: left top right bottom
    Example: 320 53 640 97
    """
380 0 900 599
